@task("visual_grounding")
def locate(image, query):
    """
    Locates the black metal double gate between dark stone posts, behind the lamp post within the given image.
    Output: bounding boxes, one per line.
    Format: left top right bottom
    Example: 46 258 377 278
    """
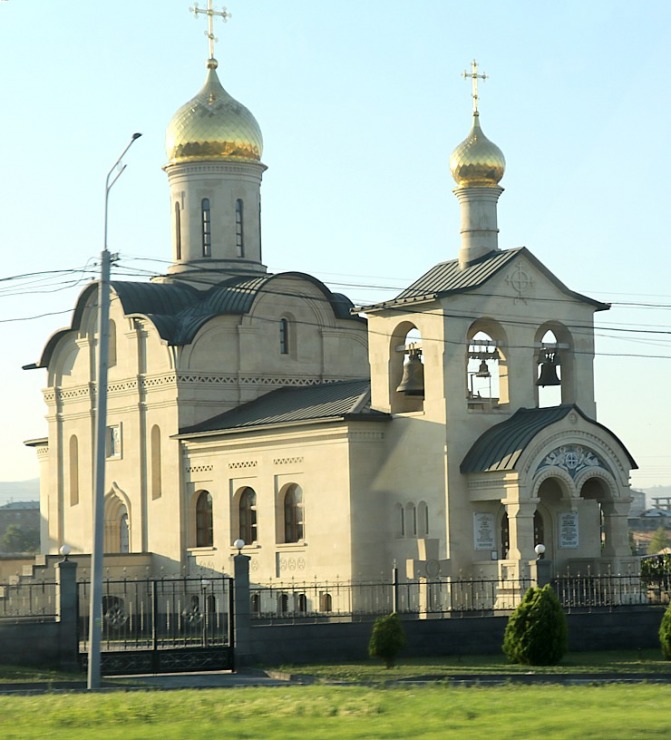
78 576 234 676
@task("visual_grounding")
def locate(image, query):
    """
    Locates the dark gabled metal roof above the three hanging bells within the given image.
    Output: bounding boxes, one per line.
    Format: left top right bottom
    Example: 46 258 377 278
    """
358 247 610 311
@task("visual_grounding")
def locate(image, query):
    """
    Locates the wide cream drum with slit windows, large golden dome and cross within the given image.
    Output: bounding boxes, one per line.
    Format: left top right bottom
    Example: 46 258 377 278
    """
164 0 266 288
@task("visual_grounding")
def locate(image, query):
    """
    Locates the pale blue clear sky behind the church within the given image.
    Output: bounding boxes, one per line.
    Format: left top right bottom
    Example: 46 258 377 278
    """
0 0 671 487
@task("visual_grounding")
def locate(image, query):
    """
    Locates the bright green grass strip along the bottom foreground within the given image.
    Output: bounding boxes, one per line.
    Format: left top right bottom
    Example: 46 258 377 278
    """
0 684 671 740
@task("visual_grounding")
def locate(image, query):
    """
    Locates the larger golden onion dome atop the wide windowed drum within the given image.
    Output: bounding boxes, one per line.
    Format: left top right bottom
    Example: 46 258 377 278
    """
165 59 263 164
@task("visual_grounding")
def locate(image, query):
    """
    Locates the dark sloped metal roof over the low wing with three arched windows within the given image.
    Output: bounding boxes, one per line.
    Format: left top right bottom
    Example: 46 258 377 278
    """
179 379 391 436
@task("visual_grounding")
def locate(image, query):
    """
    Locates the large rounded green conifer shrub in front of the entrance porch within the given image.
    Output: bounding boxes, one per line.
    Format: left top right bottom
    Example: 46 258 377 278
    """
503 584 568 665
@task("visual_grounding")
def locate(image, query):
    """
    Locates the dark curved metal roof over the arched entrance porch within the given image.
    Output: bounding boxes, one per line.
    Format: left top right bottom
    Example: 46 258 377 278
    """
460 404 638 473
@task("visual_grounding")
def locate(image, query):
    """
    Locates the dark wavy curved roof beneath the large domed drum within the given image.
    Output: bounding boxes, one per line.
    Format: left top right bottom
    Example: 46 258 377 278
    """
34 272 365 367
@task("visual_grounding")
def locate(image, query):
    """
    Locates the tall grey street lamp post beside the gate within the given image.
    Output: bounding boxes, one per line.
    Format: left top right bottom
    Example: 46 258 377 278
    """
86 134 142 689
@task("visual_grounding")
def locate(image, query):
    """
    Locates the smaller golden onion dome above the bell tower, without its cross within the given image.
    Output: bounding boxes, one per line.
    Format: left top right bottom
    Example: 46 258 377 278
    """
450 113 506 188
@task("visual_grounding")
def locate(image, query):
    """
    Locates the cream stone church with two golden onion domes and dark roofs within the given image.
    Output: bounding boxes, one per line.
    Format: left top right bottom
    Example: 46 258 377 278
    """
29 10 636 596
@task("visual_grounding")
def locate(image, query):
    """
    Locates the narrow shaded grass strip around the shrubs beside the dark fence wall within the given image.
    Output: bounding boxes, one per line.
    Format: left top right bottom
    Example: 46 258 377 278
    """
278 650 671 684
